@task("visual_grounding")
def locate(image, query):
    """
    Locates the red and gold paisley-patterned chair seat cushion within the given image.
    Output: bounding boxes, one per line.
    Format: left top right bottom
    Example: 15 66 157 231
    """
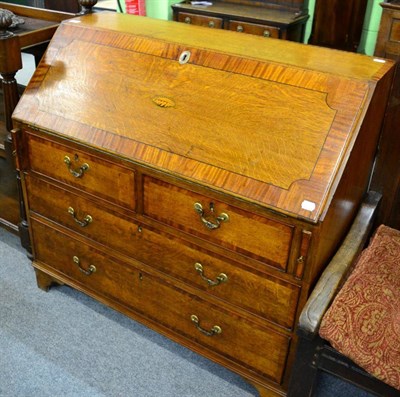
319 225 400 390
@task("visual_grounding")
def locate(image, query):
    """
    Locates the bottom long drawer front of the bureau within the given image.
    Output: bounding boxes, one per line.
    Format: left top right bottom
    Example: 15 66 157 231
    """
32 220 290 383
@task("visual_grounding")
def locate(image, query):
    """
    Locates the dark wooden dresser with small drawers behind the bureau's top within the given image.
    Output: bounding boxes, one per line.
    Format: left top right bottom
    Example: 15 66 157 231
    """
172 0 308 41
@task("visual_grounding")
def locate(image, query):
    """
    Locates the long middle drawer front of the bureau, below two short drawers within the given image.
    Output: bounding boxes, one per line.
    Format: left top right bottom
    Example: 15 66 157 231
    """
26 177 300 329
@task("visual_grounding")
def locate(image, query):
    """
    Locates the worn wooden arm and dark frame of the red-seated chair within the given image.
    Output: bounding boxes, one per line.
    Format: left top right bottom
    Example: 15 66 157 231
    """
287 192 400 397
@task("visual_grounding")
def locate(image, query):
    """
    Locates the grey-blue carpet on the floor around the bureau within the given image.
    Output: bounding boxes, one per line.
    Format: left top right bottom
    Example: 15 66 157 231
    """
0 228 376 397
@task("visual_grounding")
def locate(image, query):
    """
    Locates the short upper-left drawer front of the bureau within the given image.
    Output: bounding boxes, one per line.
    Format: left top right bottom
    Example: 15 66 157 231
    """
28 134 135 210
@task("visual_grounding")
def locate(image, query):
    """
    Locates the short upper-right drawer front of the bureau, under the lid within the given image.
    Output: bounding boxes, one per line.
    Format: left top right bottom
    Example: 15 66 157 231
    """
144 177 293 270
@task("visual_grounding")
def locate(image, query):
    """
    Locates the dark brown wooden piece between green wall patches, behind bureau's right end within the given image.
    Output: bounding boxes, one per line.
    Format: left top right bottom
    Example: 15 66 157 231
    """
309 0 368 52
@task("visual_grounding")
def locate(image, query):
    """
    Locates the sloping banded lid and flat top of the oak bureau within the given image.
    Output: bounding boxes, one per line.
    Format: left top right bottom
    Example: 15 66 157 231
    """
14 14 391 222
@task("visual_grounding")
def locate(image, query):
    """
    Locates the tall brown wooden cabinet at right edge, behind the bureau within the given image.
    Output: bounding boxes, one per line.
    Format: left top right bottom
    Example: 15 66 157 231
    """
371 1 400 229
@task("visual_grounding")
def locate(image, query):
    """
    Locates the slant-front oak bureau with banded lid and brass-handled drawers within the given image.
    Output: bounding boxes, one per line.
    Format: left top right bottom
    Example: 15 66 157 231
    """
13 13 392 396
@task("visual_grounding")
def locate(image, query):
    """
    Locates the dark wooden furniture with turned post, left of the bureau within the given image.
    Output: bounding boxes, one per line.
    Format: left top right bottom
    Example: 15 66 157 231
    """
0 0 97 244
